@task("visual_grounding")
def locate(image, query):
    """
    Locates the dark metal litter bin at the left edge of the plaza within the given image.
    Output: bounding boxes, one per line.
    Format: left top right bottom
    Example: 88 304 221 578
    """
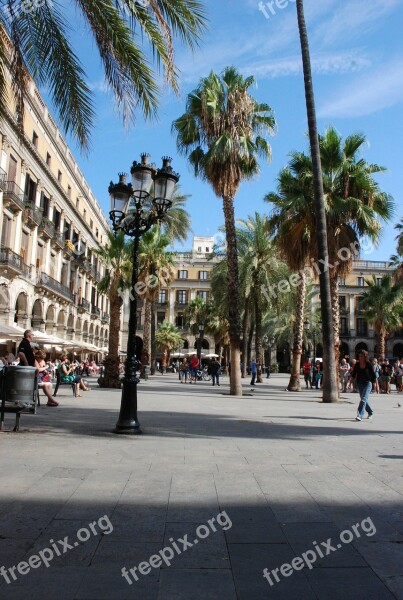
0 366 39 431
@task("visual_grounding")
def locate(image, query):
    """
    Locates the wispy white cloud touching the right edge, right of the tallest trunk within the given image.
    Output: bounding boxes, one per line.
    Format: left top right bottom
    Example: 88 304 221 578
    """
318 58 403 118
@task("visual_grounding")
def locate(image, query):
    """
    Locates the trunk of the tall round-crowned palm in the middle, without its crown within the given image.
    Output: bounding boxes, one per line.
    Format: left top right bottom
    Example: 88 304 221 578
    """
223 196 242 396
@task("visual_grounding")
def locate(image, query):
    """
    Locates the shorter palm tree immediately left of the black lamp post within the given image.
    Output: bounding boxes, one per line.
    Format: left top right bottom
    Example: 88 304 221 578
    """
94 231 133 388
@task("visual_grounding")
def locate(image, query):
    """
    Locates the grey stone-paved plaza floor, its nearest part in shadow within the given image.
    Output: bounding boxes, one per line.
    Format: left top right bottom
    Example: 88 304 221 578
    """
0 374 403 600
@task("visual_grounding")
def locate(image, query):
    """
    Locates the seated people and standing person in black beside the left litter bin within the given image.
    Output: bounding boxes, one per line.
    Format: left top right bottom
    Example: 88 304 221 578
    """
7 329 90 406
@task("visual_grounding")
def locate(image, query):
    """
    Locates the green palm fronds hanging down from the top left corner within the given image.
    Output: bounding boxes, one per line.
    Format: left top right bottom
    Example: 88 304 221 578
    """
0 0 206 149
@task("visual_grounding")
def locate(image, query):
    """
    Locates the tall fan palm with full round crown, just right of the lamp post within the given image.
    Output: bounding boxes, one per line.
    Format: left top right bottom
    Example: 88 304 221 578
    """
173 67 275 396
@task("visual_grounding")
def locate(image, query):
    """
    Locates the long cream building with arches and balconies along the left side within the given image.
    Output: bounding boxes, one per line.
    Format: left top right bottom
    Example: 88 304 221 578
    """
0 31 110 349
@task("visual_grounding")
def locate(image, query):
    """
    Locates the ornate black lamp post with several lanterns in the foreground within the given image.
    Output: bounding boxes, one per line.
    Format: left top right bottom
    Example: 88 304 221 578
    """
108 154 179 434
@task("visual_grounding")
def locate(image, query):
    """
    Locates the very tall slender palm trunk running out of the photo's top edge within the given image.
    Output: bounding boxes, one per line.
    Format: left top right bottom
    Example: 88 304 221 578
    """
296 0 339 402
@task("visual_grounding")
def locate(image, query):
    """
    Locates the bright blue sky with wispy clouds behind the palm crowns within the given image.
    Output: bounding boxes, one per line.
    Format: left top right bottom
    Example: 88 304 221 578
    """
61 0 403 260
